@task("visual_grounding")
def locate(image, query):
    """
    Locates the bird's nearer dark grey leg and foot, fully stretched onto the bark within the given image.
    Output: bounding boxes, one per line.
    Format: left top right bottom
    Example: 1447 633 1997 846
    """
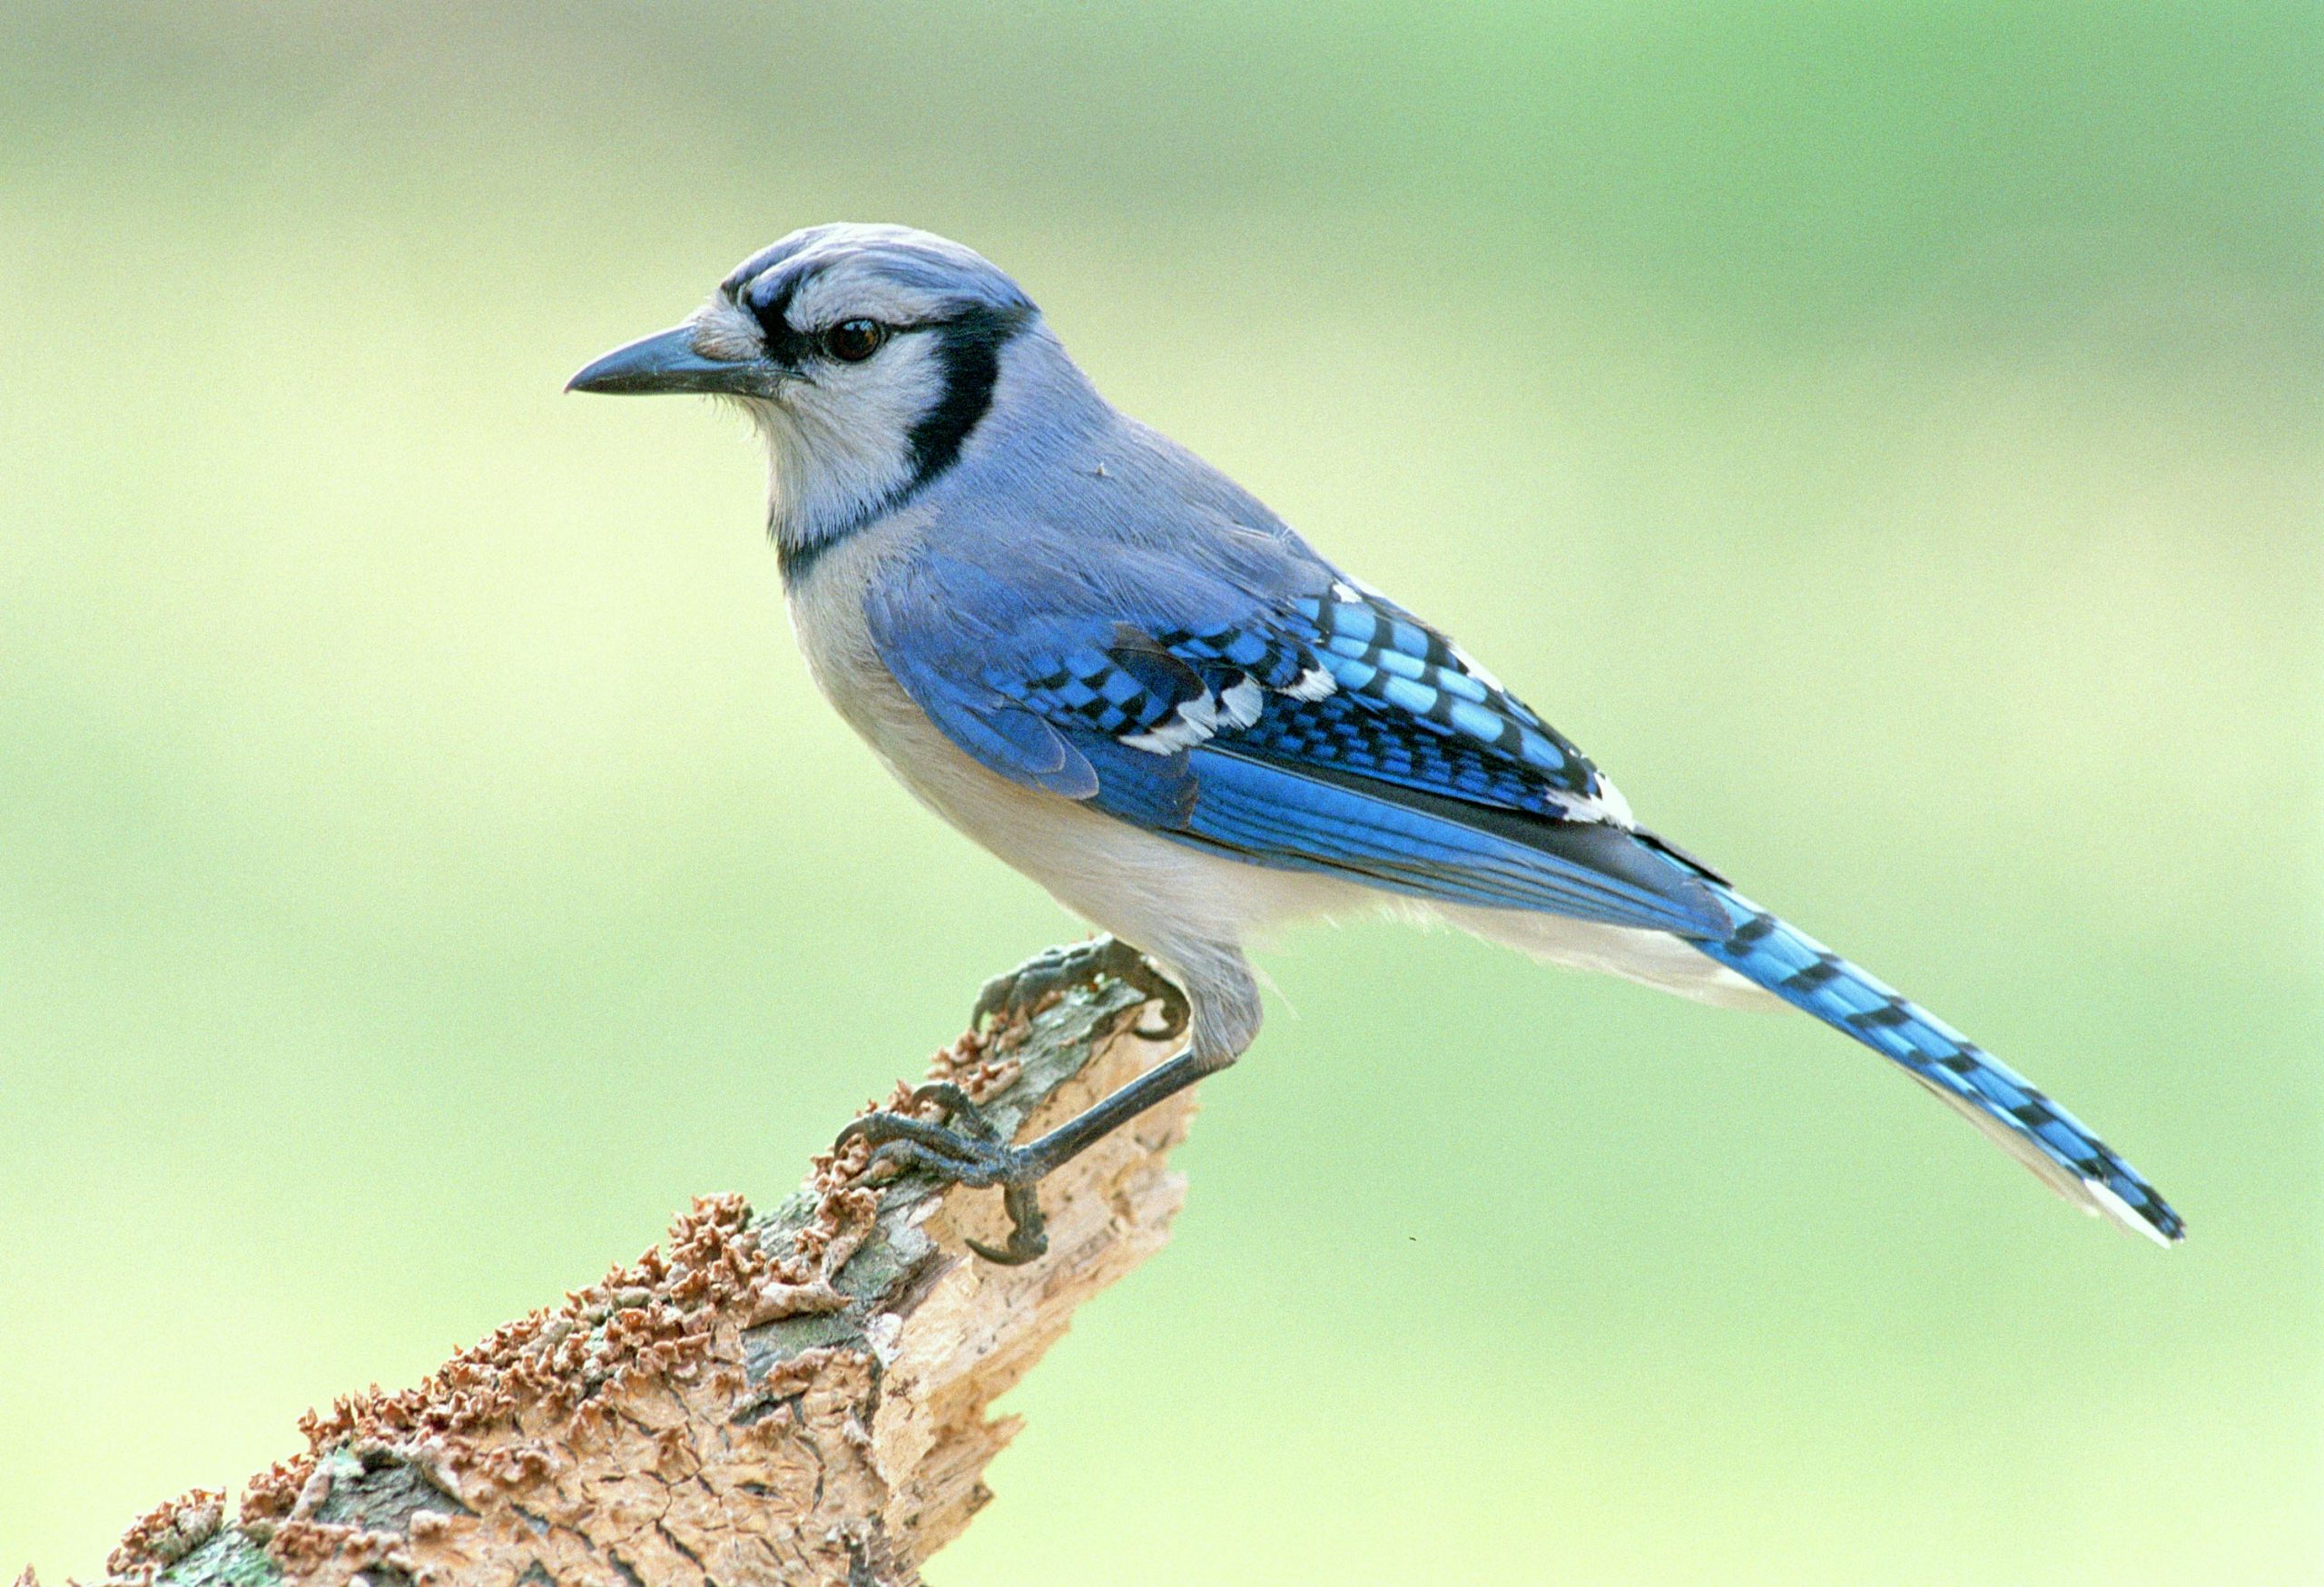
832 1048 1234 1267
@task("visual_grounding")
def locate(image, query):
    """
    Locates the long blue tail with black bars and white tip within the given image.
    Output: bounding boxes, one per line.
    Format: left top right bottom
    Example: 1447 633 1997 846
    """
1697 883 2187 1246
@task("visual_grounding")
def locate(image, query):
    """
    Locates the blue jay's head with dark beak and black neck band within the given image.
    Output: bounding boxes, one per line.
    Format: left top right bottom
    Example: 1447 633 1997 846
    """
567 225 1069 565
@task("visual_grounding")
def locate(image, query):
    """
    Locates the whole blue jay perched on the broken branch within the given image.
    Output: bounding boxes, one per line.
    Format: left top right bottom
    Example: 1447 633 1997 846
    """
567 223 2184 1264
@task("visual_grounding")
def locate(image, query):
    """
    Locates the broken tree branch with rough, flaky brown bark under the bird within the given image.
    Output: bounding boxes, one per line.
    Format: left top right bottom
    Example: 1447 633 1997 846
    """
67 961 1195 1587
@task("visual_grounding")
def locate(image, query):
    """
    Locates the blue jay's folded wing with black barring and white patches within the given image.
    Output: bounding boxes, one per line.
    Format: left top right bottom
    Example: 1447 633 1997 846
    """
867 541 1729 939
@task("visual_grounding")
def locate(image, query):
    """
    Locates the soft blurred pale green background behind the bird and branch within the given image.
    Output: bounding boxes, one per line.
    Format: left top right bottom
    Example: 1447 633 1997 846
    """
0 0 2324 1587
